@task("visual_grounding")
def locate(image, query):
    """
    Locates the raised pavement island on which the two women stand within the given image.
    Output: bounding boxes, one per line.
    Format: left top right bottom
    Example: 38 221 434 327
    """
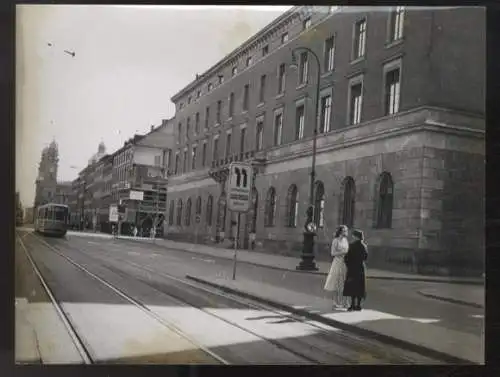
186 276 484 364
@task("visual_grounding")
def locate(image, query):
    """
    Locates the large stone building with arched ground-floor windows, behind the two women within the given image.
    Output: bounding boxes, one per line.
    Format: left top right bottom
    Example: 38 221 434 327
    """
167 7 485 273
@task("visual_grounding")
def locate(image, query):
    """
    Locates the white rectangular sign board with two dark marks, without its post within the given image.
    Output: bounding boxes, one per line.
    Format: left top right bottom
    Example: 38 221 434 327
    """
227 162 253 212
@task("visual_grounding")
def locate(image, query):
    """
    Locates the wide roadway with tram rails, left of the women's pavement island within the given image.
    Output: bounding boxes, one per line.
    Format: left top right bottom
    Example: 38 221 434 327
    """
16 231 446 364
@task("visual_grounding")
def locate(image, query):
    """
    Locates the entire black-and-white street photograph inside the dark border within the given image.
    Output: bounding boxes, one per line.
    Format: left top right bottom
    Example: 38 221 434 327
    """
14 5 485 365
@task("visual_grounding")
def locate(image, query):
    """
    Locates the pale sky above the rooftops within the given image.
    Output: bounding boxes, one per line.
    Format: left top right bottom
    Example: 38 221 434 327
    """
16 5 291 207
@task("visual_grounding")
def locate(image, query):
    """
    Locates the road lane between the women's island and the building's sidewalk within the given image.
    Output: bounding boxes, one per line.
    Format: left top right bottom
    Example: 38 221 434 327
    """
110 237 484 334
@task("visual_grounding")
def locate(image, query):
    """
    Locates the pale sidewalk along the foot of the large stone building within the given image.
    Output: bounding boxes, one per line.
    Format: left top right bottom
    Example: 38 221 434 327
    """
118 236 484 286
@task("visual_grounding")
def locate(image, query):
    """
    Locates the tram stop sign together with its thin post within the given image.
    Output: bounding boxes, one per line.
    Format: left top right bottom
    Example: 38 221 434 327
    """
227 163 253 280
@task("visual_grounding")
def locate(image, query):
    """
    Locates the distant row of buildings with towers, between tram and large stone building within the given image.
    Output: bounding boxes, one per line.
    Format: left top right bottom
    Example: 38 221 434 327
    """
35 121 173 236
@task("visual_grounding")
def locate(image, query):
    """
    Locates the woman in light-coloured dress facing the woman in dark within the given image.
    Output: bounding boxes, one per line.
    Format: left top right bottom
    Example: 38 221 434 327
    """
324 225 349 309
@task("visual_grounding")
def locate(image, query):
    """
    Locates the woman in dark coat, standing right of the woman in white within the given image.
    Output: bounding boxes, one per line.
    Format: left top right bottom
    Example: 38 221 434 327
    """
344 230 368 311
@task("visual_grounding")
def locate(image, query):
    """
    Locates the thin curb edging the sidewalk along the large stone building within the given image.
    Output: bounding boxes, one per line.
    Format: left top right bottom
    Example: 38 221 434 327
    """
116 237 484 285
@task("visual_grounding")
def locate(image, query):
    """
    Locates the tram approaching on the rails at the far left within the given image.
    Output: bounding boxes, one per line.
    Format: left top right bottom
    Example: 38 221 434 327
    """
35 203 69 237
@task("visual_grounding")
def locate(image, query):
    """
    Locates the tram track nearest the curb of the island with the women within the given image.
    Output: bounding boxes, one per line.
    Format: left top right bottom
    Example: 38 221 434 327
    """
30 232 441 364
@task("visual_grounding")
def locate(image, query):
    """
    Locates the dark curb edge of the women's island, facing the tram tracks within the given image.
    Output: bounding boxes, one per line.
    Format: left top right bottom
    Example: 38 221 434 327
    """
186 275 478 365
